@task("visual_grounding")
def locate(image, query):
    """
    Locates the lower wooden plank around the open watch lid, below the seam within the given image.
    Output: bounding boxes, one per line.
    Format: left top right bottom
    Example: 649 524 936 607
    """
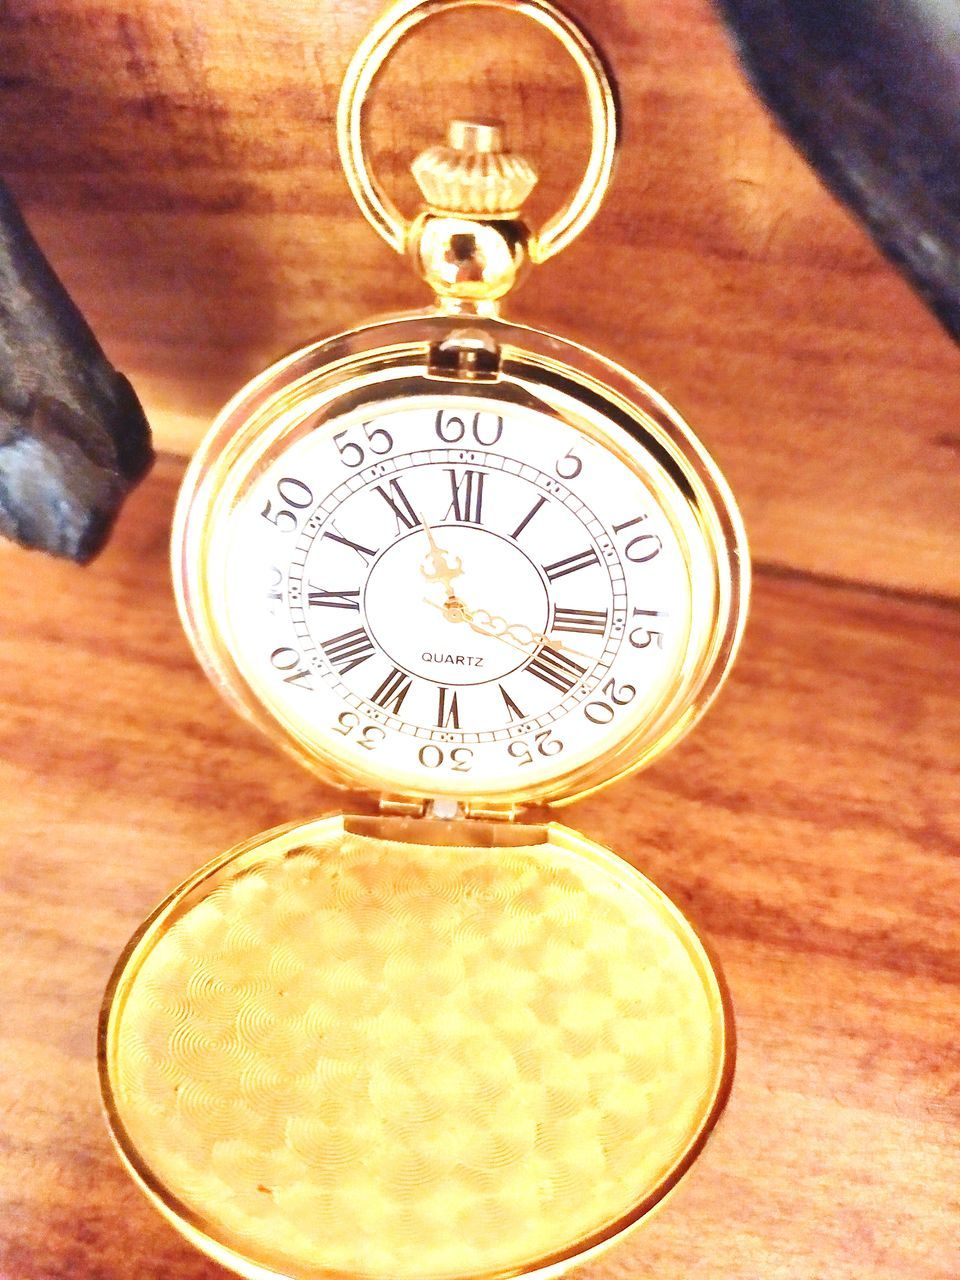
0 460 960 1280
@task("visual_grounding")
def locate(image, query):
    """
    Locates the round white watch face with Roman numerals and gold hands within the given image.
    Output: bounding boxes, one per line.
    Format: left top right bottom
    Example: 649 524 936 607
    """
179 330 752 803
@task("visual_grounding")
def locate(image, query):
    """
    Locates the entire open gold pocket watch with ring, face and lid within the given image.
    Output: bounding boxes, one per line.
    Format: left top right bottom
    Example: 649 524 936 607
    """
100 0 749 1280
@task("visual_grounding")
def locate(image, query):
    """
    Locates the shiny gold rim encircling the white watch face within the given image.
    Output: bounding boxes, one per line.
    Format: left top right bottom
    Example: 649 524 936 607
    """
172 312 750 814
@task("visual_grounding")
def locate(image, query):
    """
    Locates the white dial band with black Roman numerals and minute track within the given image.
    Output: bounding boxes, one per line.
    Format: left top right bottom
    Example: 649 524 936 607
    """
281 448 636 746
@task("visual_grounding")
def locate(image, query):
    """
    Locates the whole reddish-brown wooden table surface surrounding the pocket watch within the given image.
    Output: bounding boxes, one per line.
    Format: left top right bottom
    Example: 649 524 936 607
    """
0 0 960 1280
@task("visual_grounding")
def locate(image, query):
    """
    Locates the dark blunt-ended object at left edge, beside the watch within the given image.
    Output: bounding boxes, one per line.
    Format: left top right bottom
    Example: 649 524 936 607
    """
0 183 154 562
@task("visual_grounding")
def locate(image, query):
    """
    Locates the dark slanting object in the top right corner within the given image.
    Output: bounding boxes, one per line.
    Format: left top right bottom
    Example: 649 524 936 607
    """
716 0 960 339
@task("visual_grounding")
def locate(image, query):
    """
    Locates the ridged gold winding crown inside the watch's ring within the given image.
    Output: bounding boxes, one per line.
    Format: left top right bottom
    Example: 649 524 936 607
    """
411 120 536 216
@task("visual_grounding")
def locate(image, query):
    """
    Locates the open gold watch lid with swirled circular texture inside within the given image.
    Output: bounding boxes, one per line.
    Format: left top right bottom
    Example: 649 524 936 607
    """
100 817 733 1280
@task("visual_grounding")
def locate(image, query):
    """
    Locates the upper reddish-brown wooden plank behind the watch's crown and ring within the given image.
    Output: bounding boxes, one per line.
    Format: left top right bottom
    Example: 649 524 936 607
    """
0 0 960 596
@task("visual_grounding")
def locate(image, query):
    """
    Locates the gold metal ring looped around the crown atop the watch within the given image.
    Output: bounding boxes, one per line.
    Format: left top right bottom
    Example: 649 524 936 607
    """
337 0 620 262
